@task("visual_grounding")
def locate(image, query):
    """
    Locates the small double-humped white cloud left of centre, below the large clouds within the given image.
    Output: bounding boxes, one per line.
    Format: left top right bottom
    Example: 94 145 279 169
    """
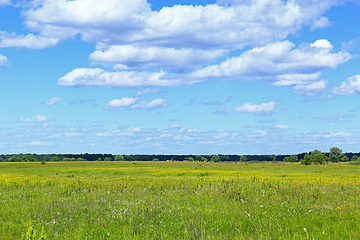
107 97 170 110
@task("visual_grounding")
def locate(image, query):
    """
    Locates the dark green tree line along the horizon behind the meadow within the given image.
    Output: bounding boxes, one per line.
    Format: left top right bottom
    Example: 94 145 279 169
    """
0 147 360 165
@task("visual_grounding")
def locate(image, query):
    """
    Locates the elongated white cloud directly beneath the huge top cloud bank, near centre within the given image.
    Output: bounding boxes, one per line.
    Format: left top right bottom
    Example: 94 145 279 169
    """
89 45 224 70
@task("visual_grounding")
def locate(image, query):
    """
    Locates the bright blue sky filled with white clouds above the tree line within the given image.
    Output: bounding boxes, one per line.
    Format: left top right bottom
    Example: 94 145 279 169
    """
0 0 360 154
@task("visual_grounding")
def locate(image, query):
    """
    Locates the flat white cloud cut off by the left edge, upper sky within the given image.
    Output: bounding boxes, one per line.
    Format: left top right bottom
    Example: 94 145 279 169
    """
0 31 59 49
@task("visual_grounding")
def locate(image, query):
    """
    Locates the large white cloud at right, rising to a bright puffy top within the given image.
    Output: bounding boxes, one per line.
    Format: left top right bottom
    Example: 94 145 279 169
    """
191 39 353 85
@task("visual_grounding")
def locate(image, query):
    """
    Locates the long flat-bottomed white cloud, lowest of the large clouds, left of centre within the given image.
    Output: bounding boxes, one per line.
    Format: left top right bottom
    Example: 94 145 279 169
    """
58 68 200 88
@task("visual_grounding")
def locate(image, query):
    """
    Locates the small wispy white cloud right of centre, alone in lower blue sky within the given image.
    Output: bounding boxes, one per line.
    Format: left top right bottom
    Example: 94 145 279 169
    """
215 101 280 115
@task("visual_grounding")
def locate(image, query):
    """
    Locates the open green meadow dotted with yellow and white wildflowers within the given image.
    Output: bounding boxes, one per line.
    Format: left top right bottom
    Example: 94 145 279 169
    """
0 162 360 239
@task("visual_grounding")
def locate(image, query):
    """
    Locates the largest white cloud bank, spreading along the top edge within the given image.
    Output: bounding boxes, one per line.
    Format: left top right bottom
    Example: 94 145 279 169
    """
23 0 334 49
